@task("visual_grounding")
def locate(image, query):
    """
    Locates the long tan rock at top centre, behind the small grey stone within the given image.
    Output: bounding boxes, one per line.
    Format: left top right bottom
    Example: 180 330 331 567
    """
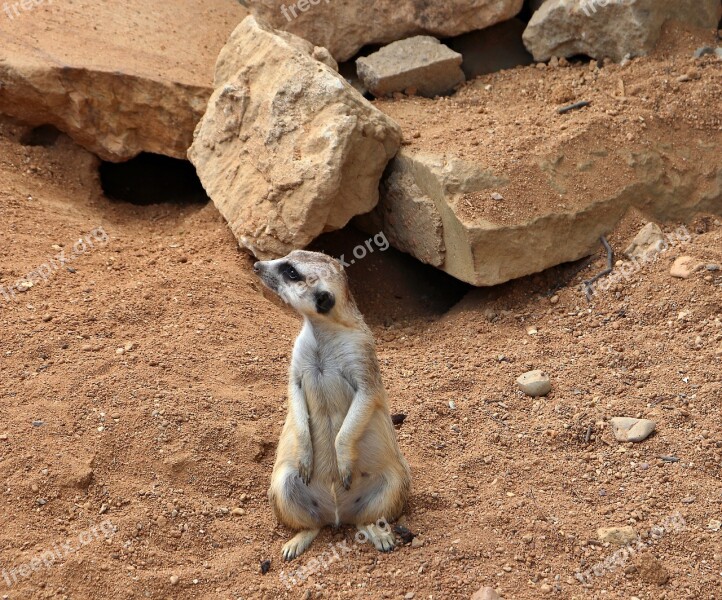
246 0 523 61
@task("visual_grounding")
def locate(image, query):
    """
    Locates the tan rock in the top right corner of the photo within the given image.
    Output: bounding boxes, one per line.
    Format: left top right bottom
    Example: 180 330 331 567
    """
524 0 722 61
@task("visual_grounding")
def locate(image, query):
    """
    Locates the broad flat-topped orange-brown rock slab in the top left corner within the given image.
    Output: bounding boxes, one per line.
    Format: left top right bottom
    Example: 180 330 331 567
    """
0 0 247 161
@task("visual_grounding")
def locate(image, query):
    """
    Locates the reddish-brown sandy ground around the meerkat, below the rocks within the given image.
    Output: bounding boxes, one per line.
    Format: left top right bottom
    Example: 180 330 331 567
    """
0 30 722 600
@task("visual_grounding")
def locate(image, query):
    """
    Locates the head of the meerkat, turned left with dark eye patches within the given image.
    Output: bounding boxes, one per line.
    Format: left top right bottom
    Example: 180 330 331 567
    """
253 250 353 319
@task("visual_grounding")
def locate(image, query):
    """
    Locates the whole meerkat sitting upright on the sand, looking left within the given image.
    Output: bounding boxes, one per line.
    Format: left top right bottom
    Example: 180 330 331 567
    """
254 250 411 560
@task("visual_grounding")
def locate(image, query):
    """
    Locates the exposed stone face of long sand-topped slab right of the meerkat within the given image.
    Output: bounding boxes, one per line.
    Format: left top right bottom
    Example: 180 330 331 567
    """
357 146 722 286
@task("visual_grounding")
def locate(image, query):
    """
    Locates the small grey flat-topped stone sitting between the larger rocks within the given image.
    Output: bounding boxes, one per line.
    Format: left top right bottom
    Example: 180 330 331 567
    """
356 35 465 98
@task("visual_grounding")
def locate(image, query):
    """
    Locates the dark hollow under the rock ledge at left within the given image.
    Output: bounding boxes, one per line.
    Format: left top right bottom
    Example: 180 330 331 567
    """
100 152 208 206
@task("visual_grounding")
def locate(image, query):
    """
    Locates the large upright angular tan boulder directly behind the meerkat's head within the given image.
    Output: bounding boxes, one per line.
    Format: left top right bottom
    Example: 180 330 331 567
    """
188 17 401 258
